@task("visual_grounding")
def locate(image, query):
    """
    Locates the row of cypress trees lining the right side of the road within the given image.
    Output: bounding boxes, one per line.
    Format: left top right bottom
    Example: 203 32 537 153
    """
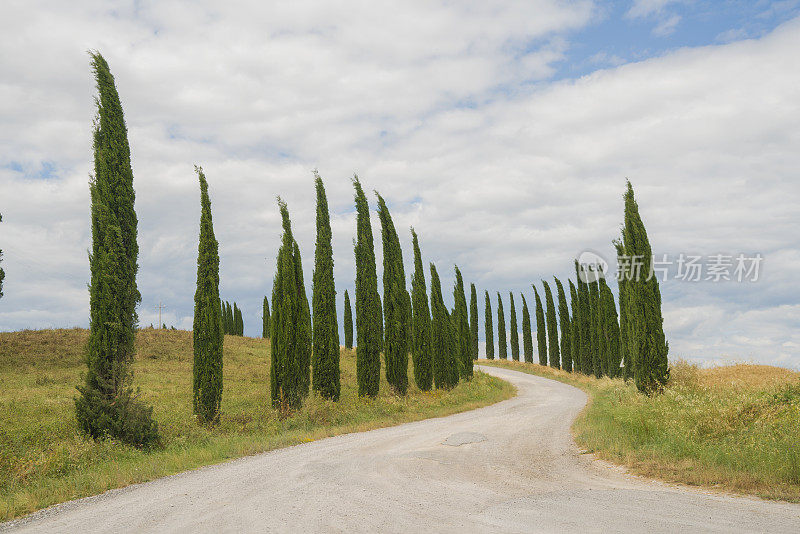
484 181 669 394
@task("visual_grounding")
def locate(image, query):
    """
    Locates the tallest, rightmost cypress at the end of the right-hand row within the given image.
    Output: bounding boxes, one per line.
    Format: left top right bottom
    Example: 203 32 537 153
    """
622 181 669 394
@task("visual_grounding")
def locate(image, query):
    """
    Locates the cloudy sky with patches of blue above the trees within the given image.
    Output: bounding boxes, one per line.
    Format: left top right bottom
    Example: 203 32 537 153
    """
0 0 800 368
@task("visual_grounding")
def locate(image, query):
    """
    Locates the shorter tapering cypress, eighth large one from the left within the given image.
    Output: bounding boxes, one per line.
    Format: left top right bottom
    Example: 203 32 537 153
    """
430 263 458 389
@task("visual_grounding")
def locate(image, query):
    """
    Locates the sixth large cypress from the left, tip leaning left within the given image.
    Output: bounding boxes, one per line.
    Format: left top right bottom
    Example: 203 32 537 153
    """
375 195 411 395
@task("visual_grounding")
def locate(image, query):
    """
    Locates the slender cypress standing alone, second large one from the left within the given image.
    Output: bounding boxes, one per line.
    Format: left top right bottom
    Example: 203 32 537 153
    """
192 166 223 423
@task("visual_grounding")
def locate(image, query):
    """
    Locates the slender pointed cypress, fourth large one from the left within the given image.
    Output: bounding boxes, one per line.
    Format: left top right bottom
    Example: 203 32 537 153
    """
311 171 341 401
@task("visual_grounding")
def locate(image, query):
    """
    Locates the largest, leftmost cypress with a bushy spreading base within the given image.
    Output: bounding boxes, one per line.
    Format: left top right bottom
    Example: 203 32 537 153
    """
75 52 158 446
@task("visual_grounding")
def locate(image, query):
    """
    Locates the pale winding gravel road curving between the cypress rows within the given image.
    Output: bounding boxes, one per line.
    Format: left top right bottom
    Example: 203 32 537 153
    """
6 367 800 534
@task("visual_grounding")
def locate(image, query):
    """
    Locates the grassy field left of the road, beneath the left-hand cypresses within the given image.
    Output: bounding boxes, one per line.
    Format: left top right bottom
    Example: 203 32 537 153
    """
0 329 514 520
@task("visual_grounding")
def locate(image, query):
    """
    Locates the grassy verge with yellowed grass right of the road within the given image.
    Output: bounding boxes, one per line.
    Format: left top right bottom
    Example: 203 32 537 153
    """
481 360 800 502
